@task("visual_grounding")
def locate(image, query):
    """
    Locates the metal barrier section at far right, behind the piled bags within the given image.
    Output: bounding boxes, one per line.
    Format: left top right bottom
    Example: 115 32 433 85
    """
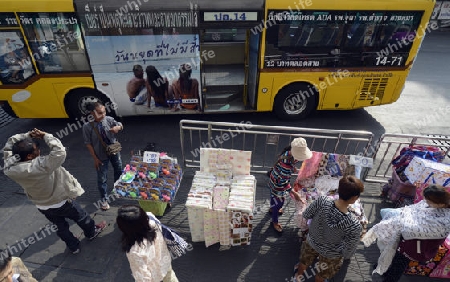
365 134 450 183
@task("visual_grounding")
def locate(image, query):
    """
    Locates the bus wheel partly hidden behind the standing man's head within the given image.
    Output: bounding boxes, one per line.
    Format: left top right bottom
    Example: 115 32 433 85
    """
64 88 117 120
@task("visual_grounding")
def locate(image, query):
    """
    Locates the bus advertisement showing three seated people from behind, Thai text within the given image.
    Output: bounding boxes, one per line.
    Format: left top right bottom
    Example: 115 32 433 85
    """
81 9 202 116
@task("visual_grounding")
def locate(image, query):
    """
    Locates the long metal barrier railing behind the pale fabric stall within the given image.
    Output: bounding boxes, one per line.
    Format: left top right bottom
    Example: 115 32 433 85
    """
180 120 374 173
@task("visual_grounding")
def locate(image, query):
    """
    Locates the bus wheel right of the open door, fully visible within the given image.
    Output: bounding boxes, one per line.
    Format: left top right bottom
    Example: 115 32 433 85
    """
273 83 318 120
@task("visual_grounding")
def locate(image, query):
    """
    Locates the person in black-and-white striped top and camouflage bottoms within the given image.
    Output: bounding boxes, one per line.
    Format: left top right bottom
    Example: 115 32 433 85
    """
296 175 364 282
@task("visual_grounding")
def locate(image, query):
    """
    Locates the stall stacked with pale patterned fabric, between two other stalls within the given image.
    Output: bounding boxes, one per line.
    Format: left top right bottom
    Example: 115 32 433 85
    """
186 148 256 247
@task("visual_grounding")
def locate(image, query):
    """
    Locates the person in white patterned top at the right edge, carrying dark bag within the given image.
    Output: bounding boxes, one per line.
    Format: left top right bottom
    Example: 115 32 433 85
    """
362 184 450 282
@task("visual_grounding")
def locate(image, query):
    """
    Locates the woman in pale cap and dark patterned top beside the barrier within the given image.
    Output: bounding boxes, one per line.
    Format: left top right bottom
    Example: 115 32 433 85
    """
268 137 312 233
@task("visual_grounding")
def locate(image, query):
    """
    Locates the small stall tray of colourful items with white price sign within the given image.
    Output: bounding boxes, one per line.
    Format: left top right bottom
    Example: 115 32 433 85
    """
113 151 183 216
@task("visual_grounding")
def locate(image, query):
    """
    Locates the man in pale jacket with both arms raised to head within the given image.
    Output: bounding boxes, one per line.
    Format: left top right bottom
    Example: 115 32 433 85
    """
3 129 106 254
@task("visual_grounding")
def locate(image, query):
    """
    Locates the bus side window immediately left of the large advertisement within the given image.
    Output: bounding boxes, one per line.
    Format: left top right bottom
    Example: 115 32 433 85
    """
20 13 90 73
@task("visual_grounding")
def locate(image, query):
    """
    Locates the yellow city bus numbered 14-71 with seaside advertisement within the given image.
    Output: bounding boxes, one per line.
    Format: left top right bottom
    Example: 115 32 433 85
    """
0 0 437 119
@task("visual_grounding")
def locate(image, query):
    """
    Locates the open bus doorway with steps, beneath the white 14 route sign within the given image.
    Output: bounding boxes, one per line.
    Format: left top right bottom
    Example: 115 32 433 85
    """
199 8 263 112
